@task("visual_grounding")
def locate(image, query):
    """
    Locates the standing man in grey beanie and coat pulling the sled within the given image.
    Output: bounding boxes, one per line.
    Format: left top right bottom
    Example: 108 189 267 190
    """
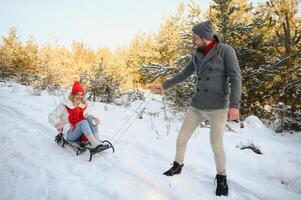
150 21 241 196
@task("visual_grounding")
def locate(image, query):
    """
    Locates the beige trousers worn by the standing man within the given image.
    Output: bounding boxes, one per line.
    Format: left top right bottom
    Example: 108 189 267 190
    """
175 107 228 175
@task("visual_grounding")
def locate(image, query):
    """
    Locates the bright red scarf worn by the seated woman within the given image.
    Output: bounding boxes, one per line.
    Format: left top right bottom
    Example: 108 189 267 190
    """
65 106 87 141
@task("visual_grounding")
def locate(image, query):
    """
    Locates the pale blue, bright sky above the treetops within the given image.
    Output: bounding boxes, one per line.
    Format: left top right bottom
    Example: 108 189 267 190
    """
0 0 298 50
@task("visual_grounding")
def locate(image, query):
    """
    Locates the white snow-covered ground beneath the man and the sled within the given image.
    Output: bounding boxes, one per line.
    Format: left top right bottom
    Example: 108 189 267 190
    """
0 83 301 200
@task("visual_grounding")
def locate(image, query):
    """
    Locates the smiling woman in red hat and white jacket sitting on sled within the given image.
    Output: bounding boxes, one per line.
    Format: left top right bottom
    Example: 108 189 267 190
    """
48 81 102 148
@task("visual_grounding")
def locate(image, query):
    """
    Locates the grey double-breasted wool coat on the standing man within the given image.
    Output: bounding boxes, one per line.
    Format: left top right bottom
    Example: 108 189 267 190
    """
162 36 242 110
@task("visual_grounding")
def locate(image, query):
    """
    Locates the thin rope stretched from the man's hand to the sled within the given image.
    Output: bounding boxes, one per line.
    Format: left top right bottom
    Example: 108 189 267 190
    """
110 94 154 144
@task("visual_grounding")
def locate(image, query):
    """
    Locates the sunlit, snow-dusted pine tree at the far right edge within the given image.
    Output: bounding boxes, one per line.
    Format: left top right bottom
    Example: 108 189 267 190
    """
254 0 301 131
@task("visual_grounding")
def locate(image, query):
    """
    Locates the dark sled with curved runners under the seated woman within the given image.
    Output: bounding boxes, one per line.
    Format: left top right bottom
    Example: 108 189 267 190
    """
55 133 115 162
